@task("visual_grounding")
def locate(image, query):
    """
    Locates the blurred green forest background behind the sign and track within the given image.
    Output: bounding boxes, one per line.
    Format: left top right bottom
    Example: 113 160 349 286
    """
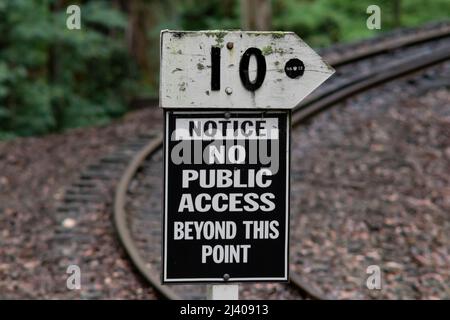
0 0 450 139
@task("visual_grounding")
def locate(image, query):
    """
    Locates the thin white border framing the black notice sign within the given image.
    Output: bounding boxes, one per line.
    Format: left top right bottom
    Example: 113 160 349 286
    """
162 109 291 283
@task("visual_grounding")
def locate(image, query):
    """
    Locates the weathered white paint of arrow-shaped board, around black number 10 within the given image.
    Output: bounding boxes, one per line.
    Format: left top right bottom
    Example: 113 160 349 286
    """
160 30 334 109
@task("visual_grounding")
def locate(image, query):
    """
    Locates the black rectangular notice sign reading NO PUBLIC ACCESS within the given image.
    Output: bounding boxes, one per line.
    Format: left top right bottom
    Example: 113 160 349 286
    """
162 110 291 282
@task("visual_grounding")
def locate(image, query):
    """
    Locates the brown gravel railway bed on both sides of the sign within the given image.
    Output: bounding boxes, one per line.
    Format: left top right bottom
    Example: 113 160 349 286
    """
0 21 450 299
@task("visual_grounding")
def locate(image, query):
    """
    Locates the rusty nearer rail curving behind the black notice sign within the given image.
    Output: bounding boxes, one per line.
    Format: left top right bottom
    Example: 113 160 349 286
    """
114 30 450 300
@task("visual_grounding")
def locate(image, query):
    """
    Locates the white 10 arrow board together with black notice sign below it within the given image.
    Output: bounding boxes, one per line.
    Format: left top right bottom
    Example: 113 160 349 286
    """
160 30 334 282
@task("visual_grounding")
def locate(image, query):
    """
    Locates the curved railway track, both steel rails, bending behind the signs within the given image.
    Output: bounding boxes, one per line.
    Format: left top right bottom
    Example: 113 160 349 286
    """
75 25 450 299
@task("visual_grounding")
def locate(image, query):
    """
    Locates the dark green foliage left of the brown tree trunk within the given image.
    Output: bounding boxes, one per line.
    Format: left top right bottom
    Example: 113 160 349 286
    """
0 0 137 139
